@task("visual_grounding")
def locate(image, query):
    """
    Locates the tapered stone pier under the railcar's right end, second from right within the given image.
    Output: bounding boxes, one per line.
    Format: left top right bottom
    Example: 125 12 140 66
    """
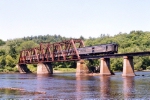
100 58 111 75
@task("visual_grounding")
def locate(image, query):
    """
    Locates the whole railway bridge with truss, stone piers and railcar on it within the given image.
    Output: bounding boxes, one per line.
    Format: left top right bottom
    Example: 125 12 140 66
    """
17 39 150 76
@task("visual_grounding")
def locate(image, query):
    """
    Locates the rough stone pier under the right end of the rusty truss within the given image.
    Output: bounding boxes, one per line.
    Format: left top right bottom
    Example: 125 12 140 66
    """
76 60 89 75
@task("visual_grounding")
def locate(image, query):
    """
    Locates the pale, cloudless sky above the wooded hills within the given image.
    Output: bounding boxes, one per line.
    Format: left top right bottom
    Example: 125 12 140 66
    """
0 0 150 40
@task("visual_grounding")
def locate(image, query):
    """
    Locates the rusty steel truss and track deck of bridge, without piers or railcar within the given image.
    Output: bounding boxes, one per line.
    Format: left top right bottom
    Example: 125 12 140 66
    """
19 39 150 64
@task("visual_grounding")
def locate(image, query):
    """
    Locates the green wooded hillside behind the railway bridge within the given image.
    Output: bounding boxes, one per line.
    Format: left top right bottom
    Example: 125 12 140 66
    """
0 31 150 72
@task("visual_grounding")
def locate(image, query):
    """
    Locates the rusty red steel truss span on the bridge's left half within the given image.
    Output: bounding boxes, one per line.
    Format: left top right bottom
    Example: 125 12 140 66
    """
19 39 84 64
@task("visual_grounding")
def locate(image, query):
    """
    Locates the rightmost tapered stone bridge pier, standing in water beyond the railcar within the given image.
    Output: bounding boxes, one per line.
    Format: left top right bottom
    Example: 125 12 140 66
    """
122 56 135 76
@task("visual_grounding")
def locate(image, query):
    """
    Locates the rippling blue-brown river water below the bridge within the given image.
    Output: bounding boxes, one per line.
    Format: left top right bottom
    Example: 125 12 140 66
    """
0 72 150 100
